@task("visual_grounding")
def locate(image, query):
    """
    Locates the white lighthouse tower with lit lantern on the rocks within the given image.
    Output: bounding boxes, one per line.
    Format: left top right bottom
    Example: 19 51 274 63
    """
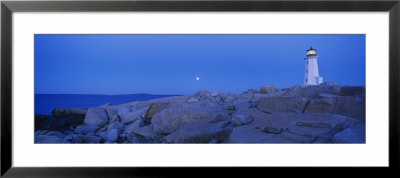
304 47 322 85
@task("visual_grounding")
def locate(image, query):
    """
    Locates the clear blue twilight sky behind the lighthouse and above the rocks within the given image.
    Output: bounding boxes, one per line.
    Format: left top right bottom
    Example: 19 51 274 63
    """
35 34 365 95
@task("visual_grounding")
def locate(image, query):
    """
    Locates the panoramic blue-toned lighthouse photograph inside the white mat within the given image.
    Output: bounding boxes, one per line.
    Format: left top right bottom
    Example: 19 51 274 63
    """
34 34 366 144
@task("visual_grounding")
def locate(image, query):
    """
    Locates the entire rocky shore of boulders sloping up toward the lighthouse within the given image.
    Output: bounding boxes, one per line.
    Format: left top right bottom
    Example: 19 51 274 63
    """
35 82 365 143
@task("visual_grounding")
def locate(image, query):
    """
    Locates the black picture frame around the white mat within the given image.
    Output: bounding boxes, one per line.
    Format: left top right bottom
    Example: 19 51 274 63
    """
1 0 400 177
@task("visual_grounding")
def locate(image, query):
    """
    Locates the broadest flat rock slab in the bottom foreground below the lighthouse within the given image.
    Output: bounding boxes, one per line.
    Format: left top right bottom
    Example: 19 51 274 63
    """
226 112 358 143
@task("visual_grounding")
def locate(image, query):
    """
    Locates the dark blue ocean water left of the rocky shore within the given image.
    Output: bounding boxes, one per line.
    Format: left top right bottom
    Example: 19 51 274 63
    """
35 94 178 115
